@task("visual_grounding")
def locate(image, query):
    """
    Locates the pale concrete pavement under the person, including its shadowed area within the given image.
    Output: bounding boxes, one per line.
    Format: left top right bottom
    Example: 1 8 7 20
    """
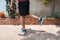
0 25 60 40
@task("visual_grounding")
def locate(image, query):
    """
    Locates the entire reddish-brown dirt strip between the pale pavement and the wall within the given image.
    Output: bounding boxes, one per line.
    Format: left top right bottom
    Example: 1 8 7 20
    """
0 15 60 25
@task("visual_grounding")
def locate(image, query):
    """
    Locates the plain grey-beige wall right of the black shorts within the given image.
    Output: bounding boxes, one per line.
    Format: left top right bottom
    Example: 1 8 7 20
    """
30 0 60 17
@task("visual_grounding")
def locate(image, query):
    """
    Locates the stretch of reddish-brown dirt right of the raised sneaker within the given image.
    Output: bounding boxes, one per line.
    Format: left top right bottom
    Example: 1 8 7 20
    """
43 18 60 25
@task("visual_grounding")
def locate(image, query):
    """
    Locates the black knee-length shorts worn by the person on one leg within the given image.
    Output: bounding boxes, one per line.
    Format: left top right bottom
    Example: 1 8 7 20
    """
18 1 29 16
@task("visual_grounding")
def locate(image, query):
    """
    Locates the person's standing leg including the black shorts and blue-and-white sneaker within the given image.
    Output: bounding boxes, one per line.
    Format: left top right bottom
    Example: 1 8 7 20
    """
18 1 29 34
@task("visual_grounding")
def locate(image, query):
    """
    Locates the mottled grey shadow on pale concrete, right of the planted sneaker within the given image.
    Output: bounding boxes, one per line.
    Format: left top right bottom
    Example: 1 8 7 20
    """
20 29 60 40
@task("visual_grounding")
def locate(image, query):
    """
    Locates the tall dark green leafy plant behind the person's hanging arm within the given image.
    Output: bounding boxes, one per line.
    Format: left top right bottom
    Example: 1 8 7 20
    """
6 0 16 18
